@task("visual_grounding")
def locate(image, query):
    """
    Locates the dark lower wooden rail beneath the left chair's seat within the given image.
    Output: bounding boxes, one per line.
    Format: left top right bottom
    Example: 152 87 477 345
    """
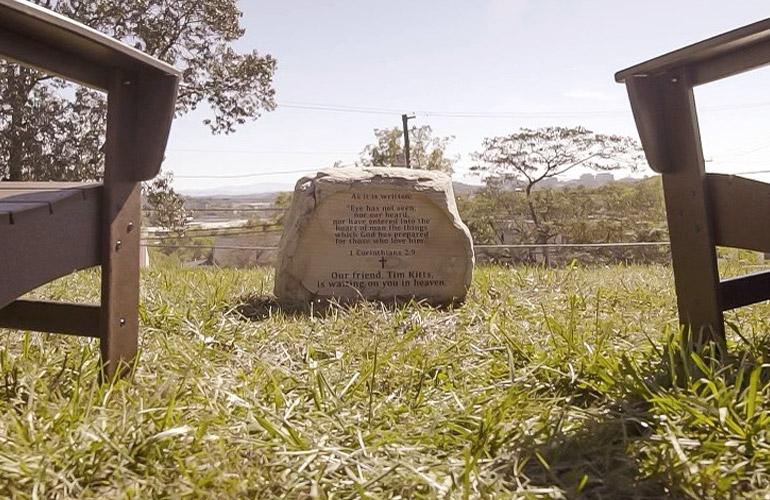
0 300 99 337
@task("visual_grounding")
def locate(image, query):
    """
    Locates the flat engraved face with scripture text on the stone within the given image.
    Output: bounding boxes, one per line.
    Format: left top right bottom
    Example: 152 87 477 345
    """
296 189 464 298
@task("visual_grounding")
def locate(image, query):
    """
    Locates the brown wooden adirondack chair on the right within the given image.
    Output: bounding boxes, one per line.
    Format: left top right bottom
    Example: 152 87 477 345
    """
615 19 770 353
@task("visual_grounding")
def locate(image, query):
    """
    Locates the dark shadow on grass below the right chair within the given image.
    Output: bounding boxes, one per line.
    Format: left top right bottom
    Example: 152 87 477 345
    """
511 330 770 499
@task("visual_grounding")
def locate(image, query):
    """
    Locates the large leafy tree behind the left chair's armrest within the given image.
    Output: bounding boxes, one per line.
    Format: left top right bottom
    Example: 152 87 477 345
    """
0 0 276 180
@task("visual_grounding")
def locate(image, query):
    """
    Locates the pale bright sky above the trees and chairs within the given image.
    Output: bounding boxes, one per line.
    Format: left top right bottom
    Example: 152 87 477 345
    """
163 0 770 193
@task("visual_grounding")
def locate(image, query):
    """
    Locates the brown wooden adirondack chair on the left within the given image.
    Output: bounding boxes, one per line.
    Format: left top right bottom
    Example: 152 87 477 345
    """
0 0 179 376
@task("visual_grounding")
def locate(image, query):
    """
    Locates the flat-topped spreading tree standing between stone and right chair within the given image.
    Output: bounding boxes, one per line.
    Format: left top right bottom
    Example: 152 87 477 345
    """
471 127 643 250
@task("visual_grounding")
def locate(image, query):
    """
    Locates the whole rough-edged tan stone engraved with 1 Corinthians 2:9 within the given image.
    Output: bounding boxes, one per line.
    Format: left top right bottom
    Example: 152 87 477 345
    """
275 167 473 307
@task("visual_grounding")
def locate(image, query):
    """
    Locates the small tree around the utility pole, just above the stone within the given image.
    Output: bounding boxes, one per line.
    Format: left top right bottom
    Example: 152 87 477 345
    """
358 125 458 173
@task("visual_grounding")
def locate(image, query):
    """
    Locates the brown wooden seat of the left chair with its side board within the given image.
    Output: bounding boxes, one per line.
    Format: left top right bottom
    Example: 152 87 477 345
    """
0 182 102 309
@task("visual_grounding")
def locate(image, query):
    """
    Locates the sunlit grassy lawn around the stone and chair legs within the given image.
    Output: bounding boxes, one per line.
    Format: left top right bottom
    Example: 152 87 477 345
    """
0 267 770 499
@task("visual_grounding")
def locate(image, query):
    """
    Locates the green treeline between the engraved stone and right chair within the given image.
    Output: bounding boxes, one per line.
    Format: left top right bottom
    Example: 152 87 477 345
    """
457 177 669 265
